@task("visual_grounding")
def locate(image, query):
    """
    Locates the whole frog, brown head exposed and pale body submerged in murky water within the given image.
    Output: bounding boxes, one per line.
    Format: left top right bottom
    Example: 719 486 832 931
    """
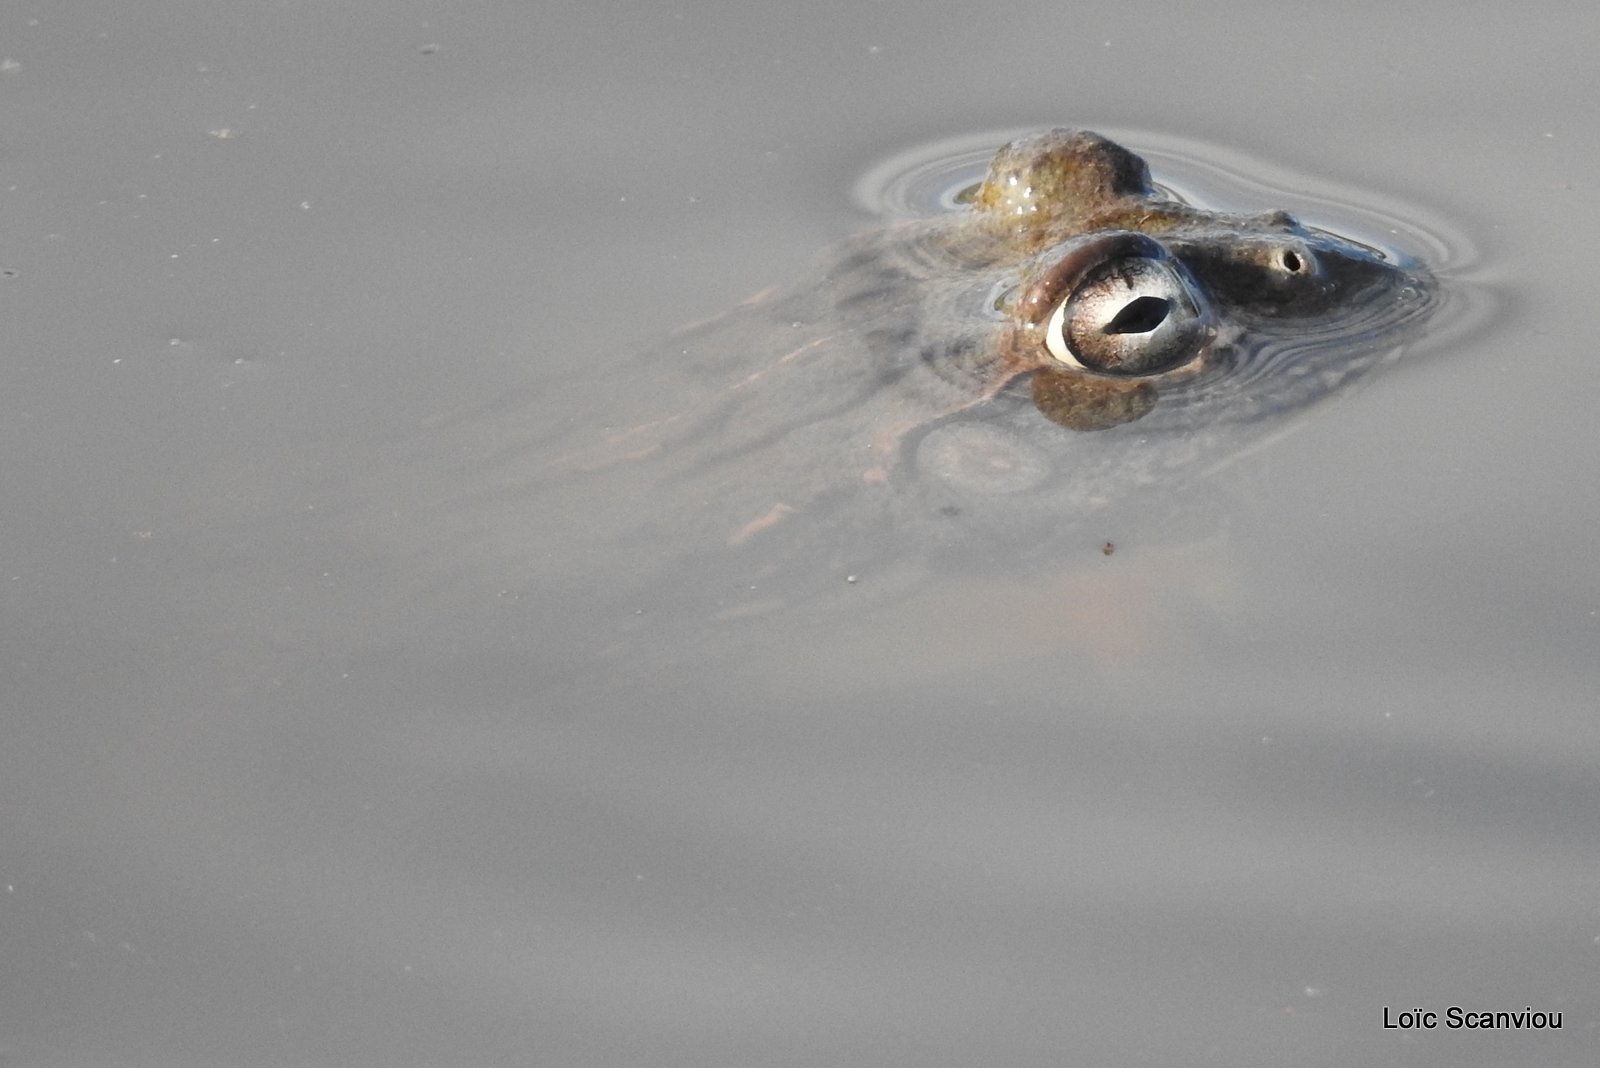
363 130 1434 620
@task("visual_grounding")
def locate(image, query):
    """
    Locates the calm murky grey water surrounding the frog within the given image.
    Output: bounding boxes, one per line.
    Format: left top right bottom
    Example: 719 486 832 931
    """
0 0 1600 1066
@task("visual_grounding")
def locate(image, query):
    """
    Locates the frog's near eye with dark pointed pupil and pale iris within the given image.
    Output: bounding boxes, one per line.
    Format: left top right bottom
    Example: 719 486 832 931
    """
1045 256 1211 376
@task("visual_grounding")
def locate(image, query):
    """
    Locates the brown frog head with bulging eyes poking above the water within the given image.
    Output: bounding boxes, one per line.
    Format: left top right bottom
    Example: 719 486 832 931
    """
950 130 1424 430
